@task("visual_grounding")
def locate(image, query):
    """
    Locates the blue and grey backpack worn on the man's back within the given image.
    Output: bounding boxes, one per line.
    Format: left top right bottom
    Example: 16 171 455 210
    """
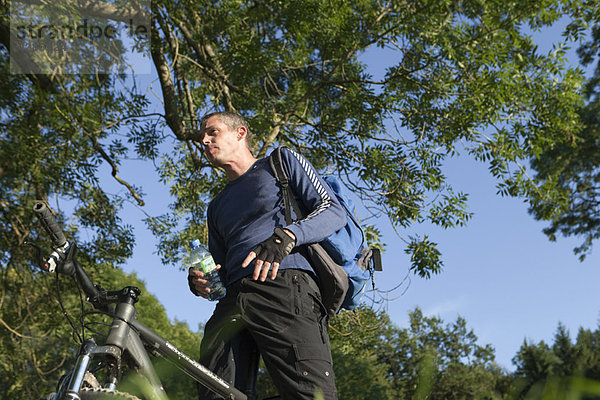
269 147 381 315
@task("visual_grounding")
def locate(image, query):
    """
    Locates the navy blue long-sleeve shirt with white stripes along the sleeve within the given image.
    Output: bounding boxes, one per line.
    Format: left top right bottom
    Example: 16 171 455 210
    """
207 148 346 285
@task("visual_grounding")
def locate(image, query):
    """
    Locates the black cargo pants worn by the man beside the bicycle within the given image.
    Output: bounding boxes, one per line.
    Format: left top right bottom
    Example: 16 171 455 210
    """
199 269 337 400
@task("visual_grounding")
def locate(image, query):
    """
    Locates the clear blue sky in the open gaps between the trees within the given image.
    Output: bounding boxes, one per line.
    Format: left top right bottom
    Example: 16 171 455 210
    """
105 17 600 370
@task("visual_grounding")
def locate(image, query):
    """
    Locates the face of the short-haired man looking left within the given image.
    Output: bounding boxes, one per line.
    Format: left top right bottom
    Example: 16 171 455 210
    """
202 115 244 167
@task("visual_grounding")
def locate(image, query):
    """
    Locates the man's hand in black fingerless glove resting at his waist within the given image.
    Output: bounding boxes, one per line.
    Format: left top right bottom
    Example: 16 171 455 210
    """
242 227 296 282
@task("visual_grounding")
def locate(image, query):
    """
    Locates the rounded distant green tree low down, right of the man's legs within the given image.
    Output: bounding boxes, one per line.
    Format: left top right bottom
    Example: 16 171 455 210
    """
388 308 510 399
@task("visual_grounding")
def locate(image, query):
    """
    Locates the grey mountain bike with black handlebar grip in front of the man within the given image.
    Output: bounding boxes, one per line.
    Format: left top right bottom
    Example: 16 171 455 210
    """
30 202 258 400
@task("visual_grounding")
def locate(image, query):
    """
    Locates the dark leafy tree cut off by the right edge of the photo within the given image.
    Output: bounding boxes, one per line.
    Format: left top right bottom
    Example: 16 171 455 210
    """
530 6 600 260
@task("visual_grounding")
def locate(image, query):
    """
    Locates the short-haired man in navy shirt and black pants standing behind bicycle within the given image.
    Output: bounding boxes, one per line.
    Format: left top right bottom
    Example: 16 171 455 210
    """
189 112 346 400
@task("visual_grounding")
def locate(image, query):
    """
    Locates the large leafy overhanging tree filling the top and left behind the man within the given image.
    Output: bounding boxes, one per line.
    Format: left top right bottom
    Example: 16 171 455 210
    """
0 0 593 395
